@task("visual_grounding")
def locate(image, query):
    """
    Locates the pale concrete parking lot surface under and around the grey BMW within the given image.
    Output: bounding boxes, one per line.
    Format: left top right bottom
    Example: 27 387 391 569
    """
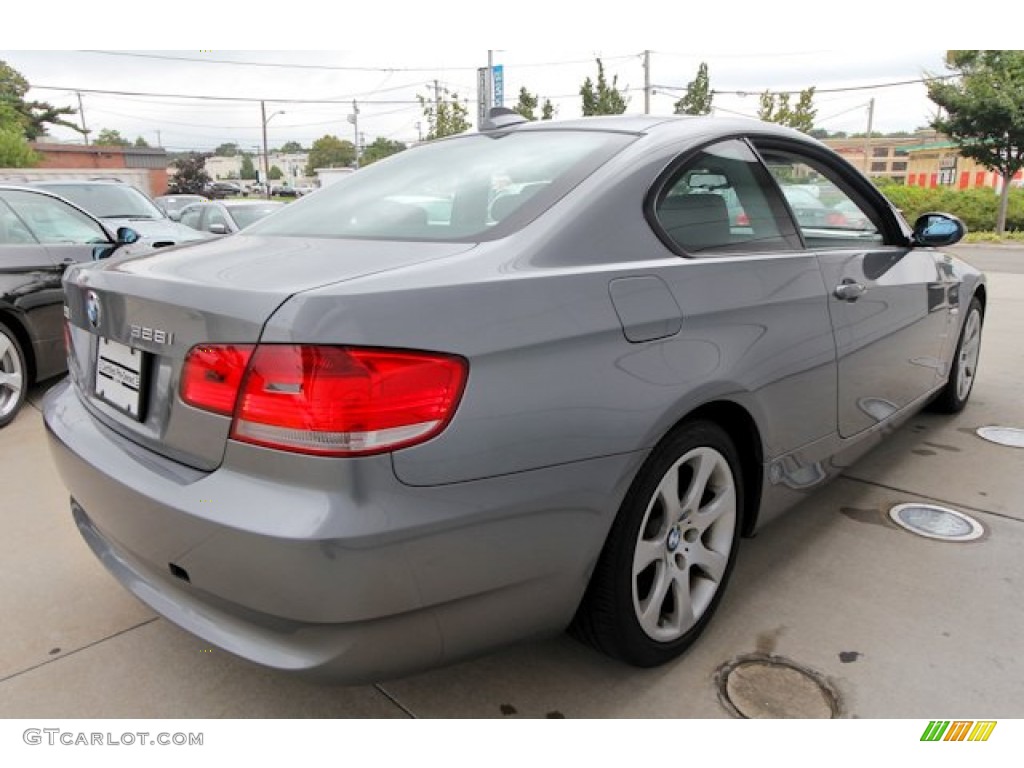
0 247 1024 720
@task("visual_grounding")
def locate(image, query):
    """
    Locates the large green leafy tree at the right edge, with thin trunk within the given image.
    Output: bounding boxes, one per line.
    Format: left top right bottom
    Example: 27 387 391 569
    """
928 50 1024 236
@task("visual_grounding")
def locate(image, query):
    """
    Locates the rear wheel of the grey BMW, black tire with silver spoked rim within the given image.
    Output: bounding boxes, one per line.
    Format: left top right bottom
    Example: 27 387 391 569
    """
570 421 743 667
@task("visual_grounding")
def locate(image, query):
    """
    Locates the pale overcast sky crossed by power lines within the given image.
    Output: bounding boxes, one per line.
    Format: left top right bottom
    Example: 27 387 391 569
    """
0 44 958 150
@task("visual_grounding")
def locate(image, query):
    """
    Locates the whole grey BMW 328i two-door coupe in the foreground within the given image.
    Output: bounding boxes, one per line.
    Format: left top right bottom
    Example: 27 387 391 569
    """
43 110 987 682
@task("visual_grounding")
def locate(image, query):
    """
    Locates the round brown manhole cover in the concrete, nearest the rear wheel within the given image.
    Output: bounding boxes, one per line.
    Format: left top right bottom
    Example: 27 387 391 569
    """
716 656 840 720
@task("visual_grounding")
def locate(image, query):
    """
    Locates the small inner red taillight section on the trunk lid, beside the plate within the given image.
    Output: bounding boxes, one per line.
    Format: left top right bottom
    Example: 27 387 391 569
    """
181 344 255 416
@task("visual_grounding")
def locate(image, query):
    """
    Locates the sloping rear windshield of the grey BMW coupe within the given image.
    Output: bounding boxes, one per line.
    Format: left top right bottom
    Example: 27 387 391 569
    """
246 130 634 241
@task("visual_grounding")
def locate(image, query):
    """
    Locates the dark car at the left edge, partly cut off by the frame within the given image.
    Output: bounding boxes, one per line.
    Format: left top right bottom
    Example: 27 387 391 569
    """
0 184 137 427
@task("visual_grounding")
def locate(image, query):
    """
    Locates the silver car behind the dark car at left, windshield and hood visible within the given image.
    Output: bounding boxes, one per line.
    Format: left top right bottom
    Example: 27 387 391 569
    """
32 181 205 248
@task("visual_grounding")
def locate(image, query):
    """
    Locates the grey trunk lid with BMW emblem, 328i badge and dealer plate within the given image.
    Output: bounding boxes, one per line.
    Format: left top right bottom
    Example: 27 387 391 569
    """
65 236 473 470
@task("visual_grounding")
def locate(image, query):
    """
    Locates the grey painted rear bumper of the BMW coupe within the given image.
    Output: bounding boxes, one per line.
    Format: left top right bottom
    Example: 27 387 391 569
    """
44 384 643 682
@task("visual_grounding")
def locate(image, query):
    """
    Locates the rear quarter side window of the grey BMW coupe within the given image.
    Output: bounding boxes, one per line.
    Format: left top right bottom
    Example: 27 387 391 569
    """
654 139 800 254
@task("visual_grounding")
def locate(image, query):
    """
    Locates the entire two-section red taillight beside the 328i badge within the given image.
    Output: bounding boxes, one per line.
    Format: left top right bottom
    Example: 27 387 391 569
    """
181 344 468 456
